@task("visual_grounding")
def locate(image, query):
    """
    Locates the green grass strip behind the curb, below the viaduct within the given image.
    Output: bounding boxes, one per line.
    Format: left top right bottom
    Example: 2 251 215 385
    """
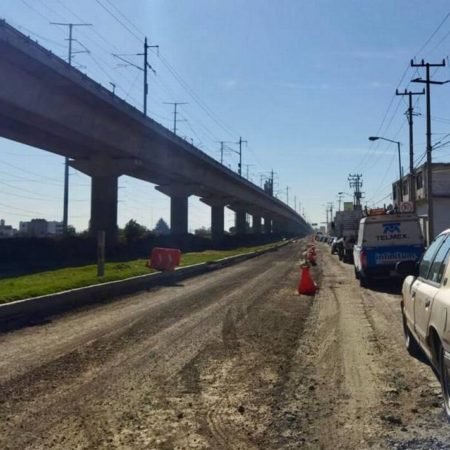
0 243 282 304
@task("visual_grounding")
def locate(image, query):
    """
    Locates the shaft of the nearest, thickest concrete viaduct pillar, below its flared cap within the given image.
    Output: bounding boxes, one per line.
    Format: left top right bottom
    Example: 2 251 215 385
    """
89 175 119 242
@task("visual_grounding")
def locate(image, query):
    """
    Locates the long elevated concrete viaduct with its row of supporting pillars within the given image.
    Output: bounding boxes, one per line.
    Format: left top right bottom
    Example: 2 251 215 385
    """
0 22 309 240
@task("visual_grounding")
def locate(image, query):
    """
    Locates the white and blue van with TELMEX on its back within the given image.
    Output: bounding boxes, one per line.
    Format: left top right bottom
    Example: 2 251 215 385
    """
353 214 424 287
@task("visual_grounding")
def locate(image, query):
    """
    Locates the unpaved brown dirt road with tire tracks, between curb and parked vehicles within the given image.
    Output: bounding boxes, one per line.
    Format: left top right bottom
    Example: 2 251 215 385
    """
0 242 450 449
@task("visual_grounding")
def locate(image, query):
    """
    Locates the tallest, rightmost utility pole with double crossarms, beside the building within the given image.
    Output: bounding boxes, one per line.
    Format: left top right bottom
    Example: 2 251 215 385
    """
411 59 447 245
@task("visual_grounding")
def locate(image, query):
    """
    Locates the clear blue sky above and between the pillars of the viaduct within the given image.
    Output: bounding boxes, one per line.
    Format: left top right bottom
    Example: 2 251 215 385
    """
0 0 450 230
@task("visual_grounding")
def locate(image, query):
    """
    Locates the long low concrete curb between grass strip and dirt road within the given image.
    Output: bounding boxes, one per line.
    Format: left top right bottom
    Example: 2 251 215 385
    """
0 240 295 330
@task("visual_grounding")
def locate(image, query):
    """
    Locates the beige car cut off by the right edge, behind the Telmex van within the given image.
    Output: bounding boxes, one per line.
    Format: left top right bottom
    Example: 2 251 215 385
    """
397 229 450 420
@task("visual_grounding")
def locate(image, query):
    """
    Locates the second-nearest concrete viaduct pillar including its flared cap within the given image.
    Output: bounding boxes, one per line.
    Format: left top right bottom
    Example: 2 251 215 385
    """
156 184 191 235
